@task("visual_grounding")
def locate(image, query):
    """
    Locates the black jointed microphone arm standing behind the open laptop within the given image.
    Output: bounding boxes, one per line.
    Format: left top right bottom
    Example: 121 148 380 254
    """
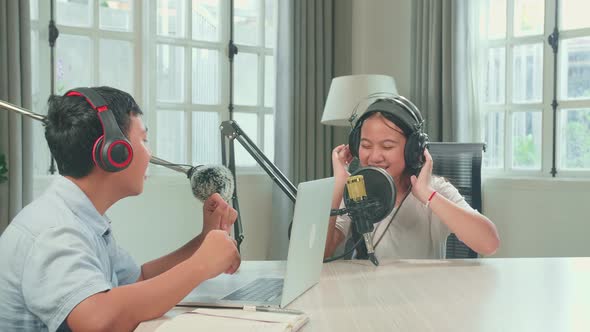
219 120 297 249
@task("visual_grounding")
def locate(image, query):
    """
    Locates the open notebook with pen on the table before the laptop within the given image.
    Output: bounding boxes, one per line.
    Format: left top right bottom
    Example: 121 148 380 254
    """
156 308 309 332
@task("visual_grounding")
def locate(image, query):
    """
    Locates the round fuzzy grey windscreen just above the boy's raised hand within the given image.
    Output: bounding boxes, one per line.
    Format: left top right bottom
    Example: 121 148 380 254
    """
189 165 234 202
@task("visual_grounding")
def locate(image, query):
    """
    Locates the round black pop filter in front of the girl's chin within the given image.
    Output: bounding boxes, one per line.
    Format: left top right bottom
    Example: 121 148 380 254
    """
344 166 397 223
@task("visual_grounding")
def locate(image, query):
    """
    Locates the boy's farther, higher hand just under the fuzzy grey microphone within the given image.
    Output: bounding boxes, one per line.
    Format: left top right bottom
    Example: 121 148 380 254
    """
202 193 238 235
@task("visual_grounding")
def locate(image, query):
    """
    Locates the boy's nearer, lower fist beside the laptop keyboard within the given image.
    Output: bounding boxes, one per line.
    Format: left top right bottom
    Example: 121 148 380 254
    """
191 230 241 279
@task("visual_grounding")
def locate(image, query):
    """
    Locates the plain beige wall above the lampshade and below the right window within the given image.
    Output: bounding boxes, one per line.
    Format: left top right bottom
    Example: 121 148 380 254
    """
352 0 590 257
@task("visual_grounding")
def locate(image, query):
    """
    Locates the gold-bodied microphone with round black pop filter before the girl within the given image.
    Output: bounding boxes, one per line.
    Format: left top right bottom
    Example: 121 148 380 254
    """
330 167 396 265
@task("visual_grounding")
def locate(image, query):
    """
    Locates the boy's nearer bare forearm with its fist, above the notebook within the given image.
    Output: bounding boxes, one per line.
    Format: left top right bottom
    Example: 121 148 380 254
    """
67 230 240 331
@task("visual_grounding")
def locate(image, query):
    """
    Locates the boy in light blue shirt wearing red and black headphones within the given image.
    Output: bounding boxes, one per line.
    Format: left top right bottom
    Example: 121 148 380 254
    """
0 87 240 331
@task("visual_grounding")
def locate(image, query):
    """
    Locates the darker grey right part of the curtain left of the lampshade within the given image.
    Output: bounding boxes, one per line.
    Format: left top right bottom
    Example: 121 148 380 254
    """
293 0 334 183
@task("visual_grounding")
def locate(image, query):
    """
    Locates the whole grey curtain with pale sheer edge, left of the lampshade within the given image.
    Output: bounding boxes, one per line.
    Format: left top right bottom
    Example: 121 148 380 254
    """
268 0 334 259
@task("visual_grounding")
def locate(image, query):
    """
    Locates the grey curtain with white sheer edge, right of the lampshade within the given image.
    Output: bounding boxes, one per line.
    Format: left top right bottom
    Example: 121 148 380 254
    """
411 0 481 142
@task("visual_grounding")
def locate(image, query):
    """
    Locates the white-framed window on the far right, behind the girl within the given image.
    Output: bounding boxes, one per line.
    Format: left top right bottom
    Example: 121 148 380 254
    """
481 0 590 175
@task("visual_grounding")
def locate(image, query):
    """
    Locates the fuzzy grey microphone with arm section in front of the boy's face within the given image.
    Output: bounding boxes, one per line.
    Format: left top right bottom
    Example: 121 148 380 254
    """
150 156 234 202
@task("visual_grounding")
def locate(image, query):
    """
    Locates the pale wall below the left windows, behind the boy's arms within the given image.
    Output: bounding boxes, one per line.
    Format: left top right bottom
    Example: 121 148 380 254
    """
35 171 274 263
